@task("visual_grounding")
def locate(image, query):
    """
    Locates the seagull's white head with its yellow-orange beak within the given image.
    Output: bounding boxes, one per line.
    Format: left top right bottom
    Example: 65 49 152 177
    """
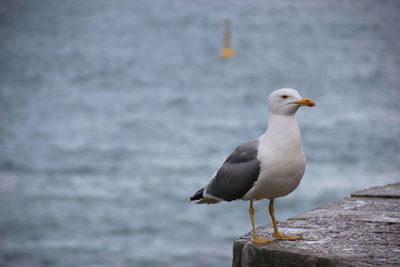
268 88 315 115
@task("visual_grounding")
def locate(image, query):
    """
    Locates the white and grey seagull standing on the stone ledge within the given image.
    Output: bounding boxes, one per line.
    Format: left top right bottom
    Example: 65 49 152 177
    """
190 88 315 243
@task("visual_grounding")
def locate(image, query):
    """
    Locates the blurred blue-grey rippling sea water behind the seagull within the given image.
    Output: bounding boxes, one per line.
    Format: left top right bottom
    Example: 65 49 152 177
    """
0 0 400 267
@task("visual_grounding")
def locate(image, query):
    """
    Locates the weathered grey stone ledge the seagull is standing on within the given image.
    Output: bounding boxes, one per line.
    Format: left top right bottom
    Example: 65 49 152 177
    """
232 183 400 267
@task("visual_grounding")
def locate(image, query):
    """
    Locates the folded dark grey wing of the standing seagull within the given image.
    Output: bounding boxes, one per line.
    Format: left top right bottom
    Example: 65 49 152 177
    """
206 140 260 201
